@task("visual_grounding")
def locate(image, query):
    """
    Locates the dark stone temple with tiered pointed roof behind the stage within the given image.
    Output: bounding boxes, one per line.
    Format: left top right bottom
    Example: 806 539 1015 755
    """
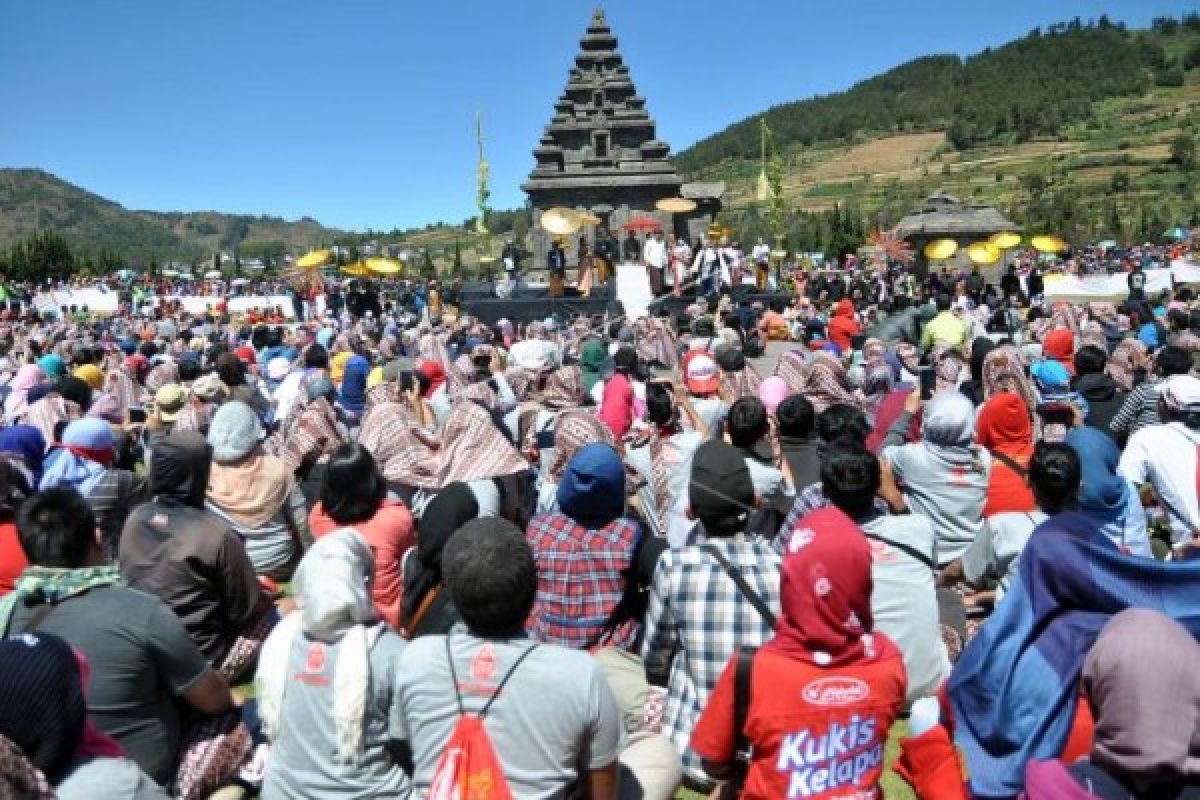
521 8 724 266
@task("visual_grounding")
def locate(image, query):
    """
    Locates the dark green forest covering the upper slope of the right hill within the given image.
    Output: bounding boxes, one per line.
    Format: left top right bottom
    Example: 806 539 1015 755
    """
674 13 1200 175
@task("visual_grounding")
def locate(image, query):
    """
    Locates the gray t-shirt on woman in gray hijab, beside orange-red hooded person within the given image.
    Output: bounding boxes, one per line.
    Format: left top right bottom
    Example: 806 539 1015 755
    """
880 441 991 566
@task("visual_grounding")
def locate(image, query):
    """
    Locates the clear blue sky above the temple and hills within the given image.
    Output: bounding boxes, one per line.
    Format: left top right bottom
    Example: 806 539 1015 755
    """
0 0 1194 229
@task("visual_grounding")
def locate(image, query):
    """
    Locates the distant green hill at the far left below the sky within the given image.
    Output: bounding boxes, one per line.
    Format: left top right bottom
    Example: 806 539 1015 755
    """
0 169 343 264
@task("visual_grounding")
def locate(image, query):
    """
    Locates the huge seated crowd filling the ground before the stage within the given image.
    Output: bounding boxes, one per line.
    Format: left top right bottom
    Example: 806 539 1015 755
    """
0 239 1200 800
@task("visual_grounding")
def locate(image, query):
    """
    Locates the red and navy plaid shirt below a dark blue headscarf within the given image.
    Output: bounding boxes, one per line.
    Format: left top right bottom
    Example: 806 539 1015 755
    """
526 512 641 648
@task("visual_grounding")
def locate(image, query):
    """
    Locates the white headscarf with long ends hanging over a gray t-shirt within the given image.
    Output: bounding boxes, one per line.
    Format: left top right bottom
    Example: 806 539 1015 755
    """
256 528 384 764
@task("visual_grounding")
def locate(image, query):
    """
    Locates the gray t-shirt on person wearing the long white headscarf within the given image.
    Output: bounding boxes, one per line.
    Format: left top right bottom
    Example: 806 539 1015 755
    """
260 631 409 800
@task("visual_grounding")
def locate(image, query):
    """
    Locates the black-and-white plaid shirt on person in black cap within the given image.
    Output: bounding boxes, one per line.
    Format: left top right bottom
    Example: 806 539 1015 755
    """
642 534 780 784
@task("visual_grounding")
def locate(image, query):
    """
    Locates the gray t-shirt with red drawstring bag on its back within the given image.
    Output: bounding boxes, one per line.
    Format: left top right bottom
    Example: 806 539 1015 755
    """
396 626 623 800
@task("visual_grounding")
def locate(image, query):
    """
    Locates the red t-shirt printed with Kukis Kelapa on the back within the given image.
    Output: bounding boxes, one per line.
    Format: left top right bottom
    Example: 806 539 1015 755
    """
691 647 907 800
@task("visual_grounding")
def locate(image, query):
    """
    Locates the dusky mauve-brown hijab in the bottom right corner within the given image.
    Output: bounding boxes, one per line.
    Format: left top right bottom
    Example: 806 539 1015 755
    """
1082 608 1200 798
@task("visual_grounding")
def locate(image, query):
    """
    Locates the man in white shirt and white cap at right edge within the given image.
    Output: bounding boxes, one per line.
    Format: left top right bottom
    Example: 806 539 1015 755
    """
1117 375 1200 551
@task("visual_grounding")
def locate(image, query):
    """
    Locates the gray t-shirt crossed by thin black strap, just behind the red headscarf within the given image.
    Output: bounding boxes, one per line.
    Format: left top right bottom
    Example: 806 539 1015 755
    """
862 515 950 702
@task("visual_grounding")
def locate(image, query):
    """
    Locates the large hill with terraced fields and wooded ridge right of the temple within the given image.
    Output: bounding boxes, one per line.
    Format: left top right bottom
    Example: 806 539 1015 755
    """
676 14 1200 252
